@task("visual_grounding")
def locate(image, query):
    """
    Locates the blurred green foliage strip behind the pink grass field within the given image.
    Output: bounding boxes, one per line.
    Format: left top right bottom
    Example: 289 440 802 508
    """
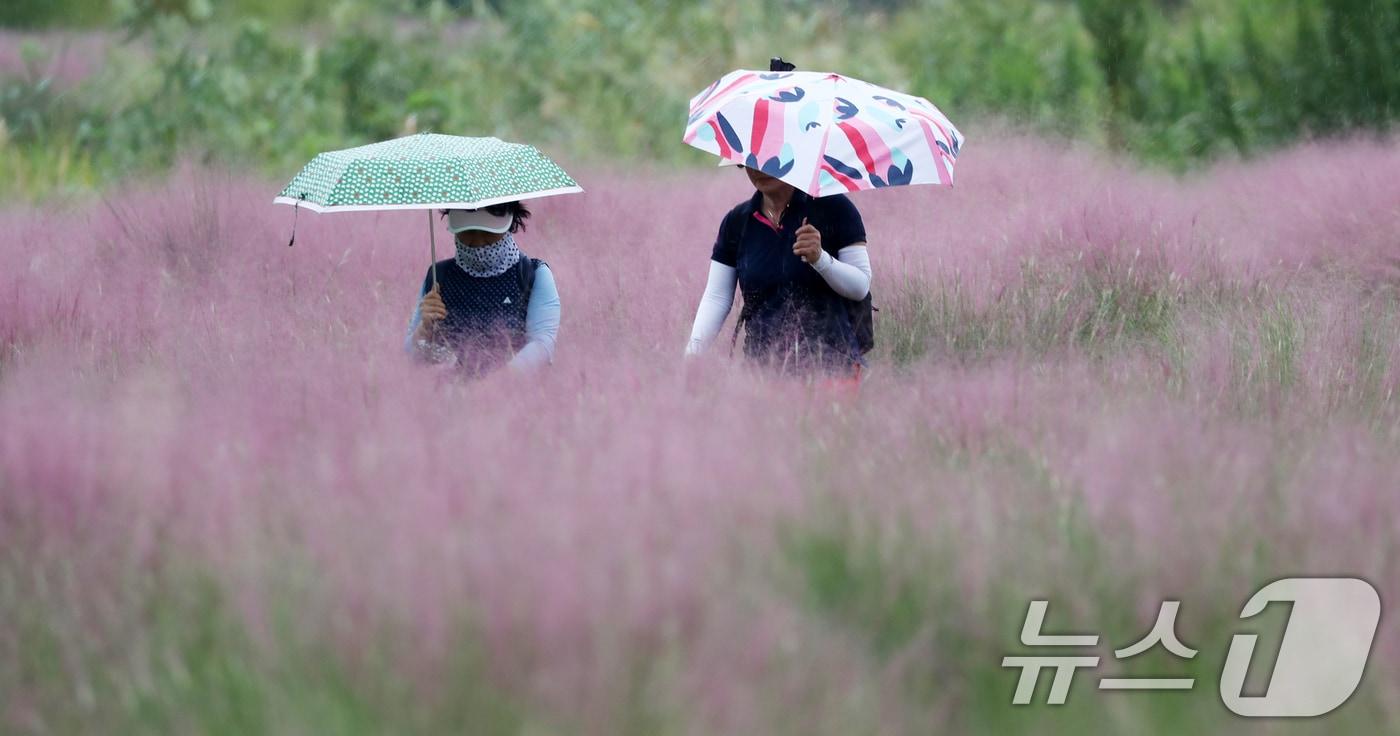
0 0 1400 194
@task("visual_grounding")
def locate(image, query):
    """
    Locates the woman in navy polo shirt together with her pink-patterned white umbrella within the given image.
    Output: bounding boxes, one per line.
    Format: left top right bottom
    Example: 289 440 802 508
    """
685 59 963 378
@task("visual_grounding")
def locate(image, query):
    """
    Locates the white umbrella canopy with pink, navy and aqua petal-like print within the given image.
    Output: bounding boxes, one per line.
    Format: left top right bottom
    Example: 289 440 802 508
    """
685 69 963 197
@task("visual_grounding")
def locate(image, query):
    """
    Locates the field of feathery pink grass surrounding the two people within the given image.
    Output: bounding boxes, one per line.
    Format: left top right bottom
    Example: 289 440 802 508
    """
0 134 1400 735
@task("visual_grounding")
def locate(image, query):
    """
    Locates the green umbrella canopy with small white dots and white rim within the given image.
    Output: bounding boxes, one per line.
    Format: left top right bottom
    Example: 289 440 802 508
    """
273 133 582 213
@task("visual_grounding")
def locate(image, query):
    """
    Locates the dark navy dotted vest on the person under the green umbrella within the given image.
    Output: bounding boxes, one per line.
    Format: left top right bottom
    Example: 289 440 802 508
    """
423 253 539 374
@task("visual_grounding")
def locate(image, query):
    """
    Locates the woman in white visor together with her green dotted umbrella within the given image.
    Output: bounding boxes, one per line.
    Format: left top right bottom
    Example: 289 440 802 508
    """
274 133 582 375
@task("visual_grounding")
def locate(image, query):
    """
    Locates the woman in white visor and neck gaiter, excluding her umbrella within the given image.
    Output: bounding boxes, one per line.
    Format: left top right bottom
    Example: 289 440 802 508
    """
406 201 560 375
